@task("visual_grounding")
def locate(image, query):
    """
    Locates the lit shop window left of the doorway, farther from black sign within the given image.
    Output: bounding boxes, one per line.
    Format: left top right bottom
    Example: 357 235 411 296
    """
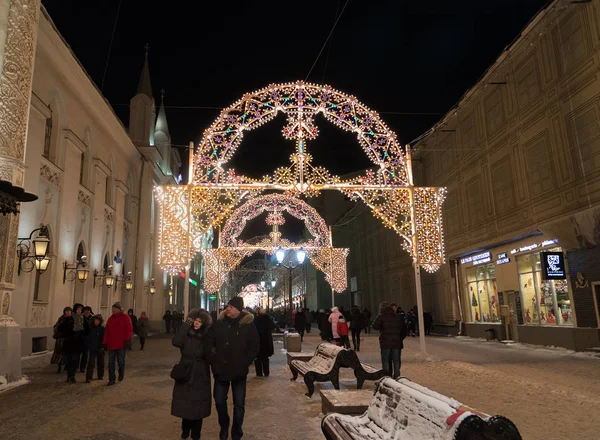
466 264 500 322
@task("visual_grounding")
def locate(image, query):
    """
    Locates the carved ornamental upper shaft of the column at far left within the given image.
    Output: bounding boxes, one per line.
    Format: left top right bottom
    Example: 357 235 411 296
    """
0 0 40 161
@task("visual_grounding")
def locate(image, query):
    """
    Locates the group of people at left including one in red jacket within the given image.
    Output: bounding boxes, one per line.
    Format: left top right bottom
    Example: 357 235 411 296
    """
50 302 150 385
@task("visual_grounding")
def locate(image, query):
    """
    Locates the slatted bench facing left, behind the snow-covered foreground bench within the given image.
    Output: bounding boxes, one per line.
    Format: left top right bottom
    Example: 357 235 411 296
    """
290 343 349 397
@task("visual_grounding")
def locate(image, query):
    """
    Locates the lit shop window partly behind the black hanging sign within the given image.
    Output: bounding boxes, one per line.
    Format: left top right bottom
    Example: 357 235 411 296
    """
517 248 573 325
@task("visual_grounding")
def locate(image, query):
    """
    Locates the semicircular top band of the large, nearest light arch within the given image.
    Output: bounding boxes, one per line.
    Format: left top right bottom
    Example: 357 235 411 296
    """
194 81 409 185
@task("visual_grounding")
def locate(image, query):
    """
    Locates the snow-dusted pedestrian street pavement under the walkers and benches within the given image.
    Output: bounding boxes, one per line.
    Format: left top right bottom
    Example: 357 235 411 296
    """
0 335 600 440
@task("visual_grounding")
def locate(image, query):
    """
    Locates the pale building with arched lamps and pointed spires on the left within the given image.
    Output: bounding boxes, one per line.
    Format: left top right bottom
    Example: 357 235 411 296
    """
9 7 181 356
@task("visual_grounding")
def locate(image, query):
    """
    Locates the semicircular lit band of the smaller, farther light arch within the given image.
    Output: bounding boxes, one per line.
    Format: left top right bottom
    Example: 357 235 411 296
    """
221 194 329 247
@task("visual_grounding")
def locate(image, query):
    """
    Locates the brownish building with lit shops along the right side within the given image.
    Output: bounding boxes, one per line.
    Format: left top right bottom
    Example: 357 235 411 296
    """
413 0 600 350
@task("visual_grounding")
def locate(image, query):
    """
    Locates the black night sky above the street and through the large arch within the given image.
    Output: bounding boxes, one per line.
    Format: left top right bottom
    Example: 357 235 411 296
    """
42 0 547 182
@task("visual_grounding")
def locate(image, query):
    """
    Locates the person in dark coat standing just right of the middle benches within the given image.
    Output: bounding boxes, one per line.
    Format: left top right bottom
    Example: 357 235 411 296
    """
373 302 406 379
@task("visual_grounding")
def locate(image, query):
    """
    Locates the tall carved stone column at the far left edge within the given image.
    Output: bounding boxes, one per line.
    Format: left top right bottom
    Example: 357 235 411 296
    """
0 0 40 382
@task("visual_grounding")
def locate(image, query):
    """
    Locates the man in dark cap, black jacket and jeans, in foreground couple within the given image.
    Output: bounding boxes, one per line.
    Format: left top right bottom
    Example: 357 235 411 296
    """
207 296 260 440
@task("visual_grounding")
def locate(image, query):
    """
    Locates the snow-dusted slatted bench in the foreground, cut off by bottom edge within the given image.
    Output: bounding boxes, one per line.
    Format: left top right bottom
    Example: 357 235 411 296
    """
321 377 521 440
